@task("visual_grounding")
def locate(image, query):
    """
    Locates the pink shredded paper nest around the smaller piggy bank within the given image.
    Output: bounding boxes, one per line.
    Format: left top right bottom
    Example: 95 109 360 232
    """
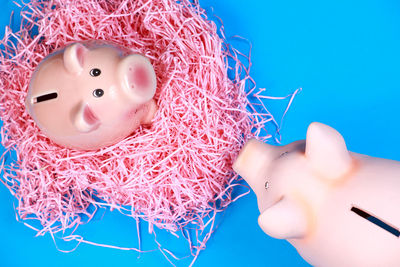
0 0 278 264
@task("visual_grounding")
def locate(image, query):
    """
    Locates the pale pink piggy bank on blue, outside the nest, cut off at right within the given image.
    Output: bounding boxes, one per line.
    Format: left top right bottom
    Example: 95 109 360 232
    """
233 123 400 267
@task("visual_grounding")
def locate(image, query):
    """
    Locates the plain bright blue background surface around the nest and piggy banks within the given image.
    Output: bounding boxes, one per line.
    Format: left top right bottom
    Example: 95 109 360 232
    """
0 0 400 266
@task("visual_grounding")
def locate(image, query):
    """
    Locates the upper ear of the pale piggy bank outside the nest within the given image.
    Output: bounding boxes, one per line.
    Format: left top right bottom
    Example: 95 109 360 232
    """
306 122 352 179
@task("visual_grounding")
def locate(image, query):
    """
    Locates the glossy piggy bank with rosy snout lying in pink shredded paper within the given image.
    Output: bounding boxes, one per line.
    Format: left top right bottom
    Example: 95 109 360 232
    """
26 41 157 150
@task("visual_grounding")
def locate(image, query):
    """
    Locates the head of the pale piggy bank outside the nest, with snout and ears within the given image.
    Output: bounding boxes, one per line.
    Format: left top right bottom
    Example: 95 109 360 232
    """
233 123 353 239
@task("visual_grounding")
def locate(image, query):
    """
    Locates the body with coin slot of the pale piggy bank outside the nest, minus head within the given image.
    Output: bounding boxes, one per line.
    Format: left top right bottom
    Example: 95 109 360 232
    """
291 154 400 267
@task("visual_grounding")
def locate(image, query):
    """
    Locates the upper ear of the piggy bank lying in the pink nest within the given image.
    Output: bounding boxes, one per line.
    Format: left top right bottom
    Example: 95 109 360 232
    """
64 43 88 75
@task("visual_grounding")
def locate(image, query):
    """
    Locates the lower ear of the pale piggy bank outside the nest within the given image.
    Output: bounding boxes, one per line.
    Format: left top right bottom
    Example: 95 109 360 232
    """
258 197 308 239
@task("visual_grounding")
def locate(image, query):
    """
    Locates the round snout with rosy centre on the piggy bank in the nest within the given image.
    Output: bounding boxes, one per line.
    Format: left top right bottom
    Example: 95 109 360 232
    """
118 54 157 104
